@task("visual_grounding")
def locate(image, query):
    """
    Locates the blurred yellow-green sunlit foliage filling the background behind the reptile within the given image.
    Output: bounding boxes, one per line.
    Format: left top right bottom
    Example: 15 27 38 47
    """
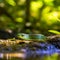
0 0 60 35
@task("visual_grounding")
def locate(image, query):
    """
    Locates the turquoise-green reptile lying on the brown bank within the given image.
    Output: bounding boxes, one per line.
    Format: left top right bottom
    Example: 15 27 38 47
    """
18 33 46 41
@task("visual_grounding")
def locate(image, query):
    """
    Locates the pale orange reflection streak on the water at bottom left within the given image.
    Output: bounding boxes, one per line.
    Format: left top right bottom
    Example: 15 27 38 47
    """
0 53 25 60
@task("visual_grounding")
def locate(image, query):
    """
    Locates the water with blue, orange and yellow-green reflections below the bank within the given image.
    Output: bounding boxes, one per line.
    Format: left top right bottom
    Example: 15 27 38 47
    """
0 43 60 60
